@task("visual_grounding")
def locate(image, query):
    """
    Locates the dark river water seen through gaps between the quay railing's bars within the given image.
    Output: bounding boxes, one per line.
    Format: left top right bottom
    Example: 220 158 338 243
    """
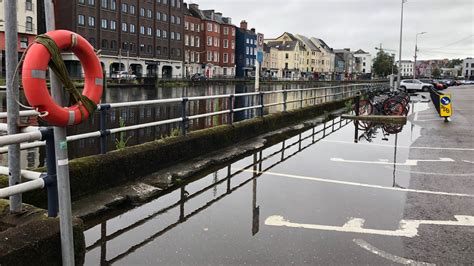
0 83 360 167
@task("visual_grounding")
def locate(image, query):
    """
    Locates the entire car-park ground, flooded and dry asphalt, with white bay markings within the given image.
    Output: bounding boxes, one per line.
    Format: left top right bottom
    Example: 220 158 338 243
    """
85 90 474 265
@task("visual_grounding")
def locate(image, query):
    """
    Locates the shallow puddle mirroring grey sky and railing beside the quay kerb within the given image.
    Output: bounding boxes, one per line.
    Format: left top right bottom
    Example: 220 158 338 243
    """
85 113 420 265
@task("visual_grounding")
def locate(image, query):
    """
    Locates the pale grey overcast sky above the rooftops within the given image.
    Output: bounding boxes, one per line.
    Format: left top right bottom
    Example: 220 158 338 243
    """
193 0 474 60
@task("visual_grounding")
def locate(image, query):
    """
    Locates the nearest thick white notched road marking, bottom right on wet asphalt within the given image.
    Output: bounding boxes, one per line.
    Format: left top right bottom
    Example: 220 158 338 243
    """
265 215 474 238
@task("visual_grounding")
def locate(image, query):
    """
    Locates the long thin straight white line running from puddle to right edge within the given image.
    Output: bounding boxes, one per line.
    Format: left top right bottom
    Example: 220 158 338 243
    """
243 169 474 198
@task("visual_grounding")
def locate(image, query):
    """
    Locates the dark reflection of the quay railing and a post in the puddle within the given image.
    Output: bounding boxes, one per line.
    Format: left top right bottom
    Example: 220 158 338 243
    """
86 118 350 265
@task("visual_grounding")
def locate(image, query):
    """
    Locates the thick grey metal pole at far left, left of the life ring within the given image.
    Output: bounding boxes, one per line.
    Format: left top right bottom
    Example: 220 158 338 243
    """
4 1 22 213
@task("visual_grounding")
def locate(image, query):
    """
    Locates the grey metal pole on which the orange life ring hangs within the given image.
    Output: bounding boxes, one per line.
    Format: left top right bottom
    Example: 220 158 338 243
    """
44 0 74 266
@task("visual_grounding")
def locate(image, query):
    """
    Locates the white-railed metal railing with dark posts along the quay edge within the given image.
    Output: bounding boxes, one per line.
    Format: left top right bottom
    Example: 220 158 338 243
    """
0 83 387 154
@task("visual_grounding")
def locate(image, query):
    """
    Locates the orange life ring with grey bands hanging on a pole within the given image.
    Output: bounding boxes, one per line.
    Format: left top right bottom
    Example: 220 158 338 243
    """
22 30 104 126
